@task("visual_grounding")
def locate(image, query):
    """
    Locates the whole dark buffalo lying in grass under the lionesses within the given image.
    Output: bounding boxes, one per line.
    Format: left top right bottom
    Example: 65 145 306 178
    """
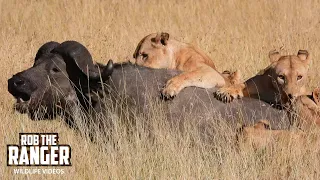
8 41 289 132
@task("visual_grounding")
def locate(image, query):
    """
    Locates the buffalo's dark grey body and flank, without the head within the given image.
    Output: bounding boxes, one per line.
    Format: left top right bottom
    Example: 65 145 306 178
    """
109 64 289 129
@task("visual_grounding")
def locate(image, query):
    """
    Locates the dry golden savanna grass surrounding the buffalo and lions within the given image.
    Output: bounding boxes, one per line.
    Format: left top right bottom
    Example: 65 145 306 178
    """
0 0 320 179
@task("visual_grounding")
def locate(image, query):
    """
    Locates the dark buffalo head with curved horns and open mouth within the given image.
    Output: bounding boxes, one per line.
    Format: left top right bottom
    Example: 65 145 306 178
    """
8 41 113 118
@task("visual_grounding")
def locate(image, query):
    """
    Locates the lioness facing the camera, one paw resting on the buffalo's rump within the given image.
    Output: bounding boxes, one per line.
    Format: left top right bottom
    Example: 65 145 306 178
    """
214 50 311 106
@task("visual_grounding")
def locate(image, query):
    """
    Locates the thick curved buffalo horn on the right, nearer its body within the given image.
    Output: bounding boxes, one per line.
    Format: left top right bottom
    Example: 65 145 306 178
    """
52 41 100 79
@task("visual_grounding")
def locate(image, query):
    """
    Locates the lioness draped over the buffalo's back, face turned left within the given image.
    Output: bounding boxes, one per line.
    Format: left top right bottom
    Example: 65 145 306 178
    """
130 32 228 97
